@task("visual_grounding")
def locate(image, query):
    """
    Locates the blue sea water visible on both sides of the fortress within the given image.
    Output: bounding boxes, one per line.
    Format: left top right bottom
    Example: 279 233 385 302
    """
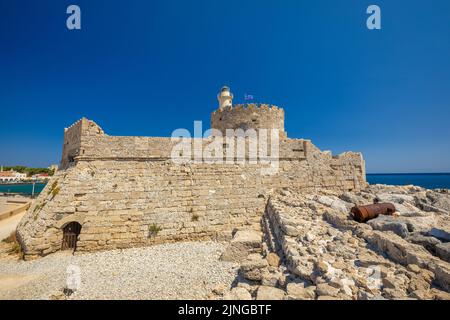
0 173 450 196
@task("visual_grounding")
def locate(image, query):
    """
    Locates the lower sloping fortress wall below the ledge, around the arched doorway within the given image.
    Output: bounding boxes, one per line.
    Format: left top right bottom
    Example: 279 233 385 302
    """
18 151 363 258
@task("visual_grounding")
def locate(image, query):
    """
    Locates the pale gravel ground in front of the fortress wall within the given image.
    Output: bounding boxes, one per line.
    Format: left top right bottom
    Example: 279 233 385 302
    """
0 242 238 299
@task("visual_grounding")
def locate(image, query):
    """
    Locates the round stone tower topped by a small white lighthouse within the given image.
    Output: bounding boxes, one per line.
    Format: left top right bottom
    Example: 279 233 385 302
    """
211 87 286 137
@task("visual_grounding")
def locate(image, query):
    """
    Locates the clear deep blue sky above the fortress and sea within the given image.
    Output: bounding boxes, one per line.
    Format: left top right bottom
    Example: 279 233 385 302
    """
0 0 450 172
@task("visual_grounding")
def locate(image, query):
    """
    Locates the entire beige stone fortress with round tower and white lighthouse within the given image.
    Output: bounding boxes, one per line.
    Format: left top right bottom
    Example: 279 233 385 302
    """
17 87 366 259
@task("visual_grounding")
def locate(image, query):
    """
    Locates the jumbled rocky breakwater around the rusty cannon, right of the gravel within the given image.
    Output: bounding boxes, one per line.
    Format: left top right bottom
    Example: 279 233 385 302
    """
214 185 450 300
